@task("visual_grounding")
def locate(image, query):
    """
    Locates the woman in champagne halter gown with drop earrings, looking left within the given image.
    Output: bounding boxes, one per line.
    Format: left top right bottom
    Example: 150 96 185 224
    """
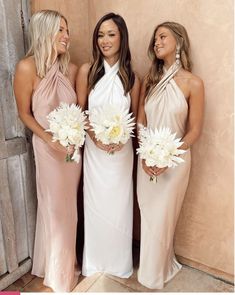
137 22 204 289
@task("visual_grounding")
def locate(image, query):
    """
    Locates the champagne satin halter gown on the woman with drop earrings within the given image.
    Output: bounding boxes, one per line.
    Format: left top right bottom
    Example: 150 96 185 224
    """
137 64 191 289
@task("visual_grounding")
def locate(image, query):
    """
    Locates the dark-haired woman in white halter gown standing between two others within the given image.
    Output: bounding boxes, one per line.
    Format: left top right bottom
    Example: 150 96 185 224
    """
77 13 139 278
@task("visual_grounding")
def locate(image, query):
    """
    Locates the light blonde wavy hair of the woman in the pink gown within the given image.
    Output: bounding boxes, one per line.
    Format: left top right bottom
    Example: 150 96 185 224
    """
26 10 70 78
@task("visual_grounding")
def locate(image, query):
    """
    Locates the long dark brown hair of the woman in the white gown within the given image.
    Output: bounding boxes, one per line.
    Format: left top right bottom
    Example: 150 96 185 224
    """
88 13 135 95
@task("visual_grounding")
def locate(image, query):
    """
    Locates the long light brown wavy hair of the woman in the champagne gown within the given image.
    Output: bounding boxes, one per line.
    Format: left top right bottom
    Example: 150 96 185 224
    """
145 21 192 96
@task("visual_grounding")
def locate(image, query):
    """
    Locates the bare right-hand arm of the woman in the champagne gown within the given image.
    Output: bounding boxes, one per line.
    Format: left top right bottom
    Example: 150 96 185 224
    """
180 76 204 149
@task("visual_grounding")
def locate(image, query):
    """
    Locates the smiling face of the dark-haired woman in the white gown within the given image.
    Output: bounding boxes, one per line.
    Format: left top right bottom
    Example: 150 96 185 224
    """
97 19 120 61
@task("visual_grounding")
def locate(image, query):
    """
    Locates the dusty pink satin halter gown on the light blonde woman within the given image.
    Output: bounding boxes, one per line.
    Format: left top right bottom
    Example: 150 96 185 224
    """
32 62 81 292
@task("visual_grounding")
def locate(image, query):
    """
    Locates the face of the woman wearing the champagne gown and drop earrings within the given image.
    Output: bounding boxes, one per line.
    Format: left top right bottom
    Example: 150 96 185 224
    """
154 27 176 60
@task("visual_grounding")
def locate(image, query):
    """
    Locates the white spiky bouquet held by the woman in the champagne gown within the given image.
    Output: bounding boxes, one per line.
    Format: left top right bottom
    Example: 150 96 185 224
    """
137 127 186 182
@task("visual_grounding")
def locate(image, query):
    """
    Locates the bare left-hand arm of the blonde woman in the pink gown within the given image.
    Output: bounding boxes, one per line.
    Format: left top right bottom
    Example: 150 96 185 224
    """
14 59 66 152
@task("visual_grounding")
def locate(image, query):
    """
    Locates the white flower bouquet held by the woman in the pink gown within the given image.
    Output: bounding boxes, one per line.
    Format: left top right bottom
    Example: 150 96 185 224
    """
46 102 87 163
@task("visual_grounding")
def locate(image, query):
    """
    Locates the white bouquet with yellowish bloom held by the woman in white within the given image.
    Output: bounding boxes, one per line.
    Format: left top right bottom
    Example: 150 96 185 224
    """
88 104 135 144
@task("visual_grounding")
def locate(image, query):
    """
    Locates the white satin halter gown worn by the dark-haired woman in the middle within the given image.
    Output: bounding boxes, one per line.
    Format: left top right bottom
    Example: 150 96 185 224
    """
82 61 133 277
